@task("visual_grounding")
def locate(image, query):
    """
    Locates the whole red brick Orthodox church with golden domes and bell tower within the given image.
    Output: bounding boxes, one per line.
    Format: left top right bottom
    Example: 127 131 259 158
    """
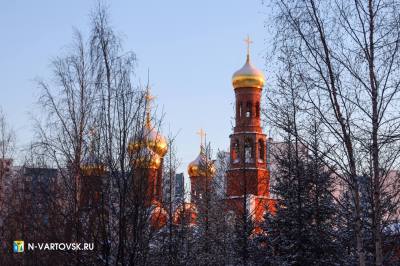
79 38 274 229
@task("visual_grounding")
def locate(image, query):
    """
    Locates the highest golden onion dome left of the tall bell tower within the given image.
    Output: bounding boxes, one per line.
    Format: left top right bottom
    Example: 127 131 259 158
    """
128 125 168 157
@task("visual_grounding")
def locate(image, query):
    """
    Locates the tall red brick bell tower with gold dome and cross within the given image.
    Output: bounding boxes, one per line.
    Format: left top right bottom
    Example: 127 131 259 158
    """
227 38 270 222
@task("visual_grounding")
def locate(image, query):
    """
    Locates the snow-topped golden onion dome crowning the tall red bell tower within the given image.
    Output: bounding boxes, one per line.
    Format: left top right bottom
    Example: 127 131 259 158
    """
232 55 265 89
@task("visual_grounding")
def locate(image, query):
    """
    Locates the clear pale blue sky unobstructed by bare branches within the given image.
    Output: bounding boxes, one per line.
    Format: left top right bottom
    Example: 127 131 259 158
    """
0 0 269 172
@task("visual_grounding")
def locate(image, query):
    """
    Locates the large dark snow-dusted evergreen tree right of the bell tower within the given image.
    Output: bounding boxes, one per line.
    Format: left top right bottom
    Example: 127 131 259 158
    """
259 125 341 265
